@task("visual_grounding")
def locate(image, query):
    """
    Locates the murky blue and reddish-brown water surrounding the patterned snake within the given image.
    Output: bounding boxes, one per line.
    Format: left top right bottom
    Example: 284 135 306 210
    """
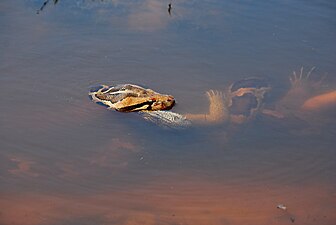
0 0 336 225
